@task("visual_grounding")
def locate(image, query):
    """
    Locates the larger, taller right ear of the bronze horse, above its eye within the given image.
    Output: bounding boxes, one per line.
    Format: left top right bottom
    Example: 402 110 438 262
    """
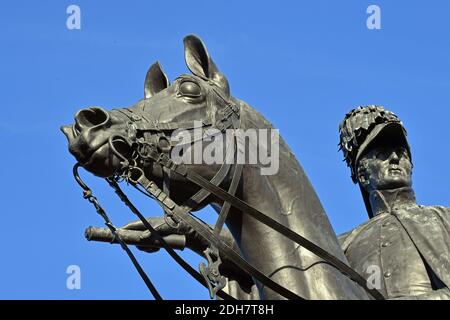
183 35 230 96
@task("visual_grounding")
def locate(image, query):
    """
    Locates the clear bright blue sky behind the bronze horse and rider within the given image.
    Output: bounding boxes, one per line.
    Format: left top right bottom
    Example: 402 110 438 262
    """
0 0 450 299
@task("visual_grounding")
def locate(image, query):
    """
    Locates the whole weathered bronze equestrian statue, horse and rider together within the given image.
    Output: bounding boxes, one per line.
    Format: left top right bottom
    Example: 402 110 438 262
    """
62 35 450 299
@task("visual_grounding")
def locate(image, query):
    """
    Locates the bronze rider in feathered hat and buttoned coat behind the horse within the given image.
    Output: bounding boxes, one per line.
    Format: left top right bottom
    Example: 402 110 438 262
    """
340 106 450 299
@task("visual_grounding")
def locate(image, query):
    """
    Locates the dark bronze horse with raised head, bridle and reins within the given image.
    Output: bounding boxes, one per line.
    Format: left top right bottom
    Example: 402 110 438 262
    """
62 35 376 299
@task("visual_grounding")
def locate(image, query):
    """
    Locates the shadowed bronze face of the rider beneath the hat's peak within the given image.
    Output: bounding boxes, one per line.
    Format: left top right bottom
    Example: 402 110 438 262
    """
358 146 412 192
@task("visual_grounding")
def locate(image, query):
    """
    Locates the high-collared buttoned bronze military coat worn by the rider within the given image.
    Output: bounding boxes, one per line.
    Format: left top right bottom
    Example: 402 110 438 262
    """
339 188 450 299
